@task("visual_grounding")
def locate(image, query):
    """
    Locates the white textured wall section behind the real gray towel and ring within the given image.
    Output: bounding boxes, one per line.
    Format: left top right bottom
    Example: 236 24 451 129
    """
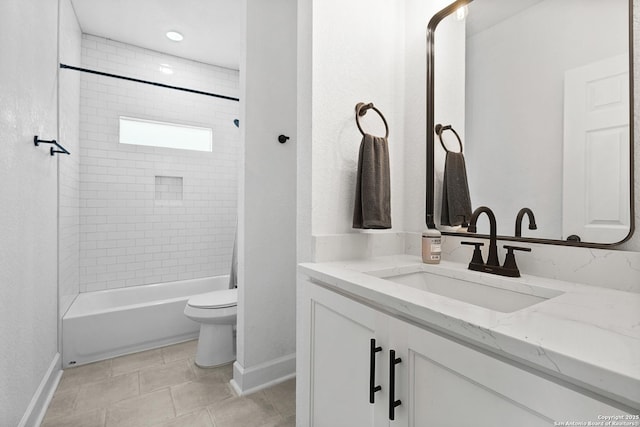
305 0 405 235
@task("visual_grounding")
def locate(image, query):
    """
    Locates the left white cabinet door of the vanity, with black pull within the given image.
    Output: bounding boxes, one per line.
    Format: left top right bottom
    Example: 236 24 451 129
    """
296 284 383 427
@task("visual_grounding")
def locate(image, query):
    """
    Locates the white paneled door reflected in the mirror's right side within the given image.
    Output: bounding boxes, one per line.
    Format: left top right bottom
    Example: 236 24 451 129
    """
562 55 631 243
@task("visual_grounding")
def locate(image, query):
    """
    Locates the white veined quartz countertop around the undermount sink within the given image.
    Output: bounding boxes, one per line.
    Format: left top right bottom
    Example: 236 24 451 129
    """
299 255 640 409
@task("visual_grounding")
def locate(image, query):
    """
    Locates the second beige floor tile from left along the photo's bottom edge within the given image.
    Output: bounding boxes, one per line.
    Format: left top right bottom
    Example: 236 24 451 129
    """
106 388 175 427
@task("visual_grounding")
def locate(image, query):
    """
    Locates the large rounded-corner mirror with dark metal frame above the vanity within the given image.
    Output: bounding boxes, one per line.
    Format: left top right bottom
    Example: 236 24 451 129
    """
426 0 633 246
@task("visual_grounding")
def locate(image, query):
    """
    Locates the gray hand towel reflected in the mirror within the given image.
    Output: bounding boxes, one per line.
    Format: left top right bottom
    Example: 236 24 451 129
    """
440 151 471 226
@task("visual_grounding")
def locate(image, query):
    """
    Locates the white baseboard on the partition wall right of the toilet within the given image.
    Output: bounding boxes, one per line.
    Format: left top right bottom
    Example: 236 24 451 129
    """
231 353 296 396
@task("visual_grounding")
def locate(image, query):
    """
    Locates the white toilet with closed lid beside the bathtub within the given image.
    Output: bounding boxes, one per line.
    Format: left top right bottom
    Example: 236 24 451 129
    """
184 288 238 368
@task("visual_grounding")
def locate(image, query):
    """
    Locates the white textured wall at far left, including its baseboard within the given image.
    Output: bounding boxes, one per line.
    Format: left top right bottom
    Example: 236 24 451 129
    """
0 0 60 426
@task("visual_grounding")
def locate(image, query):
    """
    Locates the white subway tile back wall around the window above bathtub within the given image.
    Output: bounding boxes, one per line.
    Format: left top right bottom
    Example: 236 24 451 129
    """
79 35 240 292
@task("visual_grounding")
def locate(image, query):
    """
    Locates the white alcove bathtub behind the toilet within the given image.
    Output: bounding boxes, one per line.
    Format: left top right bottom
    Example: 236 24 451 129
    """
62 276 229 367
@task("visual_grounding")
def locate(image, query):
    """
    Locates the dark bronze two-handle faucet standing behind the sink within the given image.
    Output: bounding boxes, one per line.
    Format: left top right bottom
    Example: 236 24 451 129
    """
462 206 535 277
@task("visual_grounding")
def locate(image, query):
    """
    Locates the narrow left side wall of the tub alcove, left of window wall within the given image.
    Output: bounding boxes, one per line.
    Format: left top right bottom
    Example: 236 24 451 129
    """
58 0 82 317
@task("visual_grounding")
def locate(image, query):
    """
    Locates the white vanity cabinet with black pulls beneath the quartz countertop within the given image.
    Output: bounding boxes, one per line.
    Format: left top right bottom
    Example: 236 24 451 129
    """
296 279 624 427
